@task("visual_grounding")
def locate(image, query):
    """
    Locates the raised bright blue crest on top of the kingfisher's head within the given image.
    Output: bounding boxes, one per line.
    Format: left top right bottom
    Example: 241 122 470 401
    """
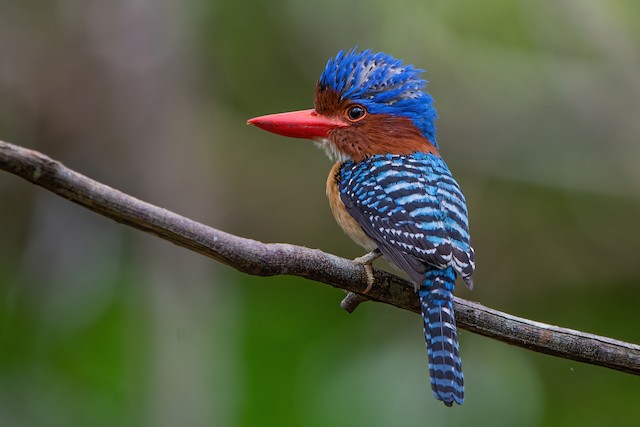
320 48 438 147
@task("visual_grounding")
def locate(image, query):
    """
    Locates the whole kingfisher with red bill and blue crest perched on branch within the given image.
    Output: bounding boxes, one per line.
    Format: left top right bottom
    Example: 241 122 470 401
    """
247 48 475 407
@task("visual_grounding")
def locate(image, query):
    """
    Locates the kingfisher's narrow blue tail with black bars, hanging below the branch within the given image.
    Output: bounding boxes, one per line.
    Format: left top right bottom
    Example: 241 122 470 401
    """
418 267 464 406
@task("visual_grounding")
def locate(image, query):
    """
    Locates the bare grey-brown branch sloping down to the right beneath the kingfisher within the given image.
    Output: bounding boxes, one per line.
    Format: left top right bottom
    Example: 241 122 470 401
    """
0 141 640 375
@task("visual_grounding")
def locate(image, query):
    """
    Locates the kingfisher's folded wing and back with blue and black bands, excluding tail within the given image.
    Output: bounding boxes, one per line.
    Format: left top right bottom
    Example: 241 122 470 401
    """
339 153 475 287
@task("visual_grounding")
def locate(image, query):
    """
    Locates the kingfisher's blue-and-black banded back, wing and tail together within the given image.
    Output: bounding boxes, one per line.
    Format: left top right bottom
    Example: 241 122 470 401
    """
339 153 474 406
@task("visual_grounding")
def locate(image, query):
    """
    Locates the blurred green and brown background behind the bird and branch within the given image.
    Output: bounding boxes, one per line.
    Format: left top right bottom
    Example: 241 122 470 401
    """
0 0 640 427
